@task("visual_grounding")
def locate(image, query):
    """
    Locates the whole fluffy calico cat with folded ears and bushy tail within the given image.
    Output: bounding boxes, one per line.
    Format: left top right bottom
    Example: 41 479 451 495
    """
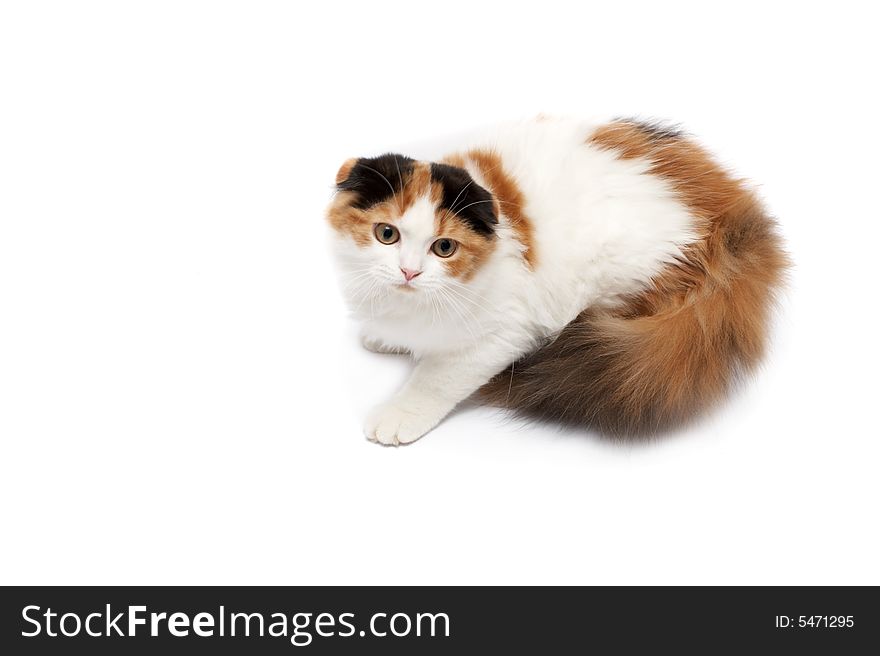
327 117 787 445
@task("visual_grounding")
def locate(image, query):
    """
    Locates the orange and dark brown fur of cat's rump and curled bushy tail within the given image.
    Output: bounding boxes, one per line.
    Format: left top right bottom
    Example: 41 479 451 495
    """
480 122 787 436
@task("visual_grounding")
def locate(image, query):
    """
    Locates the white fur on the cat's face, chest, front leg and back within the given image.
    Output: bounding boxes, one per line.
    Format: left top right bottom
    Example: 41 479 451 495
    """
336 119 698 444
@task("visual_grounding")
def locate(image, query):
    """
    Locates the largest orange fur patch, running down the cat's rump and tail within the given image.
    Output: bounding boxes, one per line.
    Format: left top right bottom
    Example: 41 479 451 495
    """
589 121 789 414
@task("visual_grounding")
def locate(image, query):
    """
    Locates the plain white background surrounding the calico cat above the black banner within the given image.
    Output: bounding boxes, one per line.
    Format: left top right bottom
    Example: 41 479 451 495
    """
0 1 880 584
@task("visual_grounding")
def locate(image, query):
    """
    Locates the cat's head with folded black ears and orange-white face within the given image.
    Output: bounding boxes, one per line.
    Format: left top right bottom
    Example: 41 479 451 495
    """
327 153 498 302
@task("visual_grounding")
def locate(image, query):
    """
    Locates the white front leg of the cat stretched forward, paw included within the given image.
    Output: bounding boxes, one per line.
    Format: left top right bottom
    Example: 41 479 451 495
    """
364 341 526 445
